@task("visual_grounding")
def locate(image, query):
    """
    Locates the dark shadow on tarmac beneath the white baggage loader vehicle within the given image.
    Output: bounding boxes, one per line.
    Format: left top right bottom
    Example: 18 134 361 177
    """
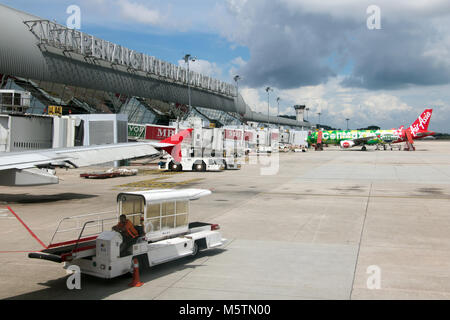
4 248 226 300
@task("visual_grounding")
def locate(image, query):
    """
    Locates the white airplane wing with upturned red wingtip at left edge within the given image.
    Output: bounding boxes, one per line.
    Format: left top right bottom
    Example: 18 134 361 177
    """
0 129 192 187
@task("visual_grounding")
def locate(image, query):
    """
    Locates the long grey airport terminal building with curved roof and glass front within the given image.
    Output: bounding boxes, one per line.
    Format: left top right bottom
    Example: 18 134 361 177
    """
0 5 310 128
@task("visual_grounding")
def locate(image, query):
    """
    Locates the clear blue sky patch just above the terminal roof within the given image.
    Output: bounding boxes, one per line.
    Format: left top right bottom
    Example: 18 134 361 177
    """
0 0 249 70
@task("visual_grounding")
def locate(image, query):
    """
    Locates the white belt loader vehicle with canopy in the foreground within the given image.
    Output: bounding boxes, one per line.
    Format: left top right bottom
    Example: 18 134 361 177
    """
29 189 226 279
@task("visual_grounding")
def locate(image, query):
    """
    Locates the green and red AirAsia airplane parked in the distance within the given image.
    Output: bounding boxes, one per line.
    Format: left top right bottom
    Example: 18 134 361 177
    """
307 109 435 151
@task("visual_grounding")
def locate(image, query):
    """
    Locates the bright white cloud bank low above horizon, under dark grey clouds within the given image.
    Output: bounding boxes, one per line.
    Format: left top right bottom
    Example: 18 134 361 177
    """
240 78 450 132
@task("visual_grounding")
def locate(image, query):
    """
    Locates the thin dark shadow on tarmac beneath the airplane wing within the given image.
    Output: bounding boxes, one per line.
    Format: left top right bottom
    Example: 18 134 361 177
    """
0 193 98 204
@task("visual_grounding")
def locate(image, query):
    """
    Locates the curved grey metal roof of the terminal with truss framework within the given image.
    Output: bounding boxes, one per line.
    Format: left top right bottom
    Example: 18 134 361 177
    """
0 4 310 127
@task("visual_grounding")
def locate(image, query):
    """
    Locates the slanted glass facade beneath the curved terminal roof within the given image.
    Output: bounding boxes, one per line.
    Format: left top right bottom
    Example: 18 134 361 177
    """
2 77 264 127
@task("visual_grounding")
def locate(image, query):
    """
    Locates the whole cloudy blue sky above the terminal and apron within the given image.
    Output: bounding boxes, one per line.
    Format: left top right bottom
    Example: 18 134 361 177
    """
0 0 450 133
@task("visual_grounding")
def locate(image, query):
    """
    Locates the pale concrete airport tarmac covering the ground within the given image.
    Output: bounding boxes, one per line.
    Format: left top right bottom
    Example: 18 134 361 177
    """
0 141 450 300
